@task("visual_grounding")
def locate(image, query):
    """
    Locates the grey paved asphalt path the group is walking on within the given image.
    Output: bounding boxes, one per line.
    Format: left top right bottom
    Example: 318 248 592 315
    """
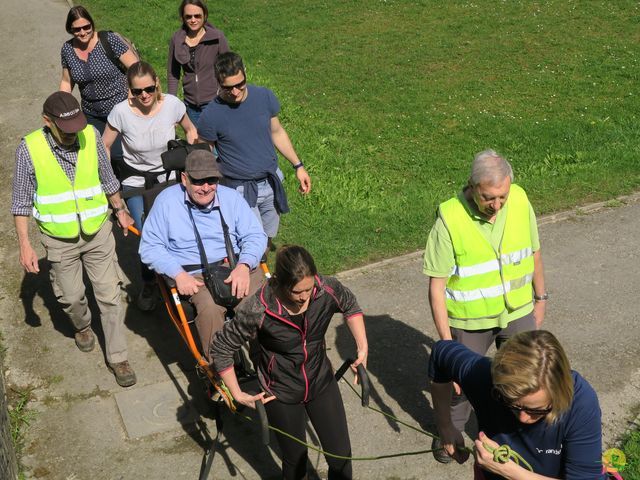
0 0 640 480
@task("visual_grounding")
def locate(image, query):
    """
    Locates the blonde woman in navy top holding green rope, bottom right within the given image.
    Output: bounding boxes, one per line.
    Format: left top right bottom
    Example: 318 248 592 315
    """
429 330 605 480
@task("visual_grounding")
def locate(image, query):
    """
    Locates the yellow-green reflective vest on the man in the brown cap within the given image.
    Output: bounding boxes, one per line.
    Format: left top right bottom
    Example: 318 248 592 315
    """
24 125 108 238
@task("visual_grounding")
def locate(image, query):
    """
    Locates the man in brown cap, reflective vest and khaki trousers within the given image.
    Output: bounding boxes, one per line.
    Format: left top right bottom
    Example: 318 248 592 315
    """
11 92 136 387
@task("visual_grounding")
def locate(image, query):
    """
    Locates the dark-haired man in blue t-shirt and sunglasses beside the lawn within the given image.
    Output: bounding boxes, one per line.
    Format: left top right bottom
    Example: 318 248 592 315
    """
198 52 311 253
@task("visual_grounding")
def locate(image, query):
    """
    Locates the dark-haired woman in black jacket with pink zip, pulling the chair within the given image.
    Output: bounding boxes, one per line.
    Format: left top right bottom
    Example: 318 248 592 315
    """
211 245 368 480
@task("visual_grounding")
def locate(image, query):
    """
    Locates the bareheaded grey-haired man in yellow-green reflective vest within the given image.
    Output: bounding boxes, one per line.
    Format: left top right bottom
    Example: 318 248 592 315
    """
423 150 548 463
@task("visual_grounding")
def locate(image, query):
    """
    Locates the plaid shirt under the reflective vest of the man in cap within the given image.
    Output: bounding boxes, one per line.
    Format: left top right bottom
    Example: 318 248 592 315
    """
11 127 120 217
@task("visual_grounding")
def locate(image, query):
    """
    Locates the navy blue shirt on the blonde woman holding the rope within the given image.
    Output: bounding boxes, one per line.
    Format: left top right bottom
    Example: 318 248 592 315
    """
429 340 605 480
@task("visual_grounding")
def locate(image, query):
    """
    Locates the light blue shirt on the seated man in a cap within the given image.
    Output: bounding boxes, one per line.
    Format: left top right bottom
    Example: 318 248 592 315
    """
138 184 267 278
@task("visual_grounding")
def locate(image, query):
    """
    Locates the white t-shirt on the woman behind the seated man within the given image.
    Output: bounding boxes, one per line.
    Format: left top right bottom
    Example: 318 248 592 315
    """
107 94 187 187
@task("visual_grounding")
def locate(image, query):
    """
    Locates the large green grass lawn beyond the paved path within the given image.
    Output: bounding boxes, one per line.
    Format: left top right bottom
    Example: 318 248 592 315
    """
81 0 640 273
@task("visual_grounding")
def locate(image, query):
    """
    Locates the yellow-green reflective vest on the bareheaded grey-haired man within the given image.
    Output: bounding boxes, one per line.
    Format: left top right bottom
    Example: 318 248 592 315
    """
438 185 533 330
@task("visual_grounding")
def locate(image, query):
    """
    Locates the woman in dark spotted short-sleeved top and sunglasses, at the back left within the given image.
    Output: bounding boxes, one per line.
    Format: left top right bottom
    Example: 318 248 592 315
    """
60 5 138 173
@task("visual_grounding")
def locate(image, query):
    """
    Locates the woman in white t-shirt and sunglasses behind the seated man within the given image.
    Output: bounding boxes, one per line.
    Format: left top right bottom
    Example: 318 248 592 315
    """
102 62 198 311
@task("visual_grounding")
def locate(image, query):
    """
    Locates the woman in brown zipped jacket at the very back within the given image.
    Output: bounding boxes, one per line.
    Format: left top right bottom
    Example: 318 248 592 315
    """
167 0 229 125
